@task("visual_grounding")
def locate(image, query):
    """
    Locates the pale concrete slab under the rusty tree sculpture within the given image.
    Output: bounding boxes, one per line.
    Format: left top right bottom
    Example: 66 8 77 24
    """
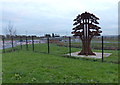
67 52 112 59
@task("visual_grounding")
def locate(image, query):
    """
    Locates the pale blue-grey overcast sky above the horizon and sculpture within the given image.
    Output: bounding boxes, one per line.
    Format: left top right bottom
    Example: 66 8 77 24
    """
0 0 119 35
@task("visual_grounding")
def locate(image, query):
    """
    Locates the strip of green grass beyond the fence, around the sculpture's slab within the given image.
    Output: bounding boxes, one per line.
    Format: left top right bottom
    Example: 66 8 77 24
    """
28 44 119 63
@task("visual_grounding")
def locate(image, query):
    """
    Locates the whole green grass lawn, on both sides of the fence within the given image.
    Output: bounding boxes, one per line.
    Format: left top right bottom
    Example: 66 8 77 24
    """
2 44 118 83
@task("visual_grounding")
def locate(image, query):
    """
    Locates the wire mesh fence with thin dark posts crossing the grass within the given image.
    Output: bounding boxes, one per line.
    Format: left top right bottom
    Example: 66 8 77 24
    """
2 36 119 62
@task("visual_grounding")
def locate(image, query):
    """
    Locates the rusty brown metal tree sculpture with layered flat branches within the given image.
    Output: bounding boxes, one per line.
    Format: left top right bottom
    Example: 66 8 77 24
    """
72 12 102 55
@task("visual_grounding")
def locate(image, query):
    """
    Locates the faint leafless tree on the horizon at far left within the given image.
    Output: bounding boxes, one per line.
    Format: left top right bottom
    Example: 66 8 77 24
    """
5 21 17 37
